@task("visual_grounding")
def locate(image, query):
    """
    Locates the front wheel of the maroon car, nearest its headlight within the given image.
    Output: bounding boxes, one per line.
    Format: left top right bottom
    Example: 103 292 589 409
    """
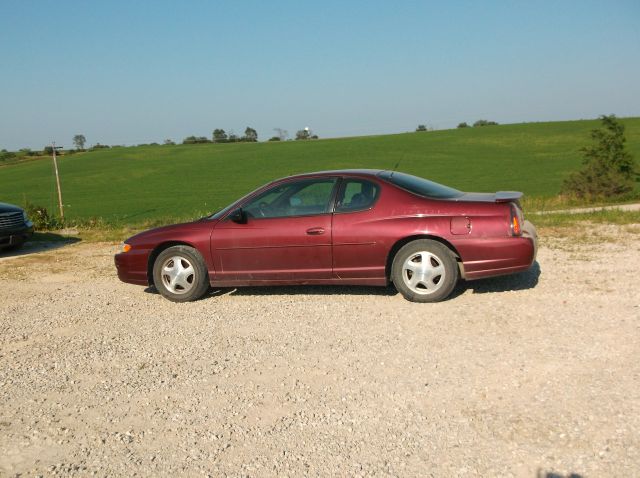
153 246 209 302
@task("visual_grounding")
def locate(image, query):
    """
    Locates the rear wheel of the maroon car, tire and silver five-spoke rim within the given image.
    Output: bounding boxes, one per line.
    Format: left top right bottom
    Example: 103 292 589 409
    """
391 239 459 302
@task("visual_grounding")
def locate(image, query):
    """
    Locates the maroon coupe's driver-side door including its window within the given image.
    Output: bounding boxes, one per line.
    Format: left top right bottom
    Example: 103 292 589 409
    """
211 177 337 282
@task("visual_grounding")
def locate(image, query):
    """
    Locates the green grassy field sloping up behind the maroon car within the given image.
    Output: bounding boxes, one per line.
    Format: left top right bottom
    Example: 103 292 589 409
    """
0 118 640 226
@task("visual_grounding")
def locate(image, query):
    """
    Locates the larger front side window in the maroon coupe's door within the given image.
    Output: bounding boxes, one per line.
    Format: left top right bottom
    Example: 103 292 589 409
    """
242 178 337 218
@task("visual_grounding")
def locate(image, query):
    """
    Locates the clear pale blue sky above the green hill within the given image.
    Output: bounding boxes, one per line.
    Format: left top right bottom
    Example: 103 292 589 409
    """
0 0 640 149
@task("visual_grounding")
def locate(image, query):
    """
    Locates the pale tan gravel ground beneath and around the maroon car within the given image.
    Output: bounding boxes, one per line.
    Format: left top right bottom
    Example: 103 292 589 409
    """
0 225 640 477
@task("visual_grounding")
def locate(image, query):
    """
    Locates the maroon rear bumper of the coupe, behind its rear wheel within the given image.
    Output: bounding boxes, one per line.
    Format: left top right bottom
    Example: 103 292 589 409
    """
461 221 538 280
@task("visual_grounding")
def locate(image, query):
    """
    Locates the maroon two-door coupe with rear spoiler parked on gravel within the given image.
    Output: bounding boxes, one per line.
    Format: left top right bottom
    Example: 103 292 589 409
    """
115 170 537 302
